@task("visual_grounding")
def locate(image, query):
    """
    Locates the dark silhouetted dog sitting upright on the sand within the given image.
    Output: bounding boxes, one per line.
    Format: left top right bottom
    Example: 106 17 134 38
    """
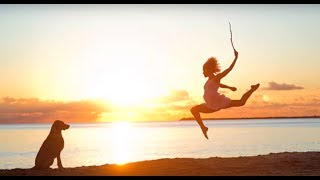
32 120 70 170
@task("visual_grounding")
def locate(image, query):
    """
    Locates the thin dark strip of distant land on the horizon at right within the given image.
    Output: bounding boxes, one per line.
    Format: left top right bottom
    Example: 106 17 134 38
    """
179 116 320 121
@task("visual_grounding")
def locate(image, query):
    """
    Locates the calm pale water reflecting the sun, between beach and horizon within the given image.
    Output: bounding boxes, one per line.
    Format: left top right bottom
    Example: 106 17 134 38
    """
0 118 320 169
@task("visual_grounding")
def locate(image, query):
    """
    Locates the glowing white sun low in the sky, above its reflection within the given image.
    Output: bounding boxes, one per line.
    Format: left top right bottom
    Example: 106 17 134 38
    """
77 62 161 107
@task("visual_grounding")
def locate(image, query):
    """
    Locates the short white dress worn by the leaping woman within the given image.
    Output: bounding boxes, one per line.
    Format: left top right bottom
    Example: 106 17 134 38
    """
203 79 231 110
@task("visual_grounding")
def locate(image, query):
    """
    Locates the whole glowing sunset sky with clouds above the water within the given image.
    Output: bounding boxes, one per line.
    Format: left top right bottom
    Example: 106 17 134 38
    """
0 4 320 123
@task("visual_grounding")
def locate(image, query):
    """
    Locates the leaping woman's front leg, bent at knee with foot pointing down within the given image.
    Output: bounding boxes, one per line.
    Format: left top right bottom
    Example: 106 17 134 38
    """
190 104 215 139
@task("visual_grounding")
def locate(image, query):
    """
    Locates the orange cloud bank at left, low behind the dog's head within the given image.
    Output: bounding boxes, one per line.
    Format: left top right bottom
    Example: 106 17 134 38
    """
0 97 111 123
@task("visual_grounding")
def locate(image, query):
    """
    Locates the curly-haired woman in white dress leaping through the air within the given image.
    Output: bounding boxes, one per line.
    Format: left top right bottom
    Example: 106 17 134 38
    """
190 49 260 139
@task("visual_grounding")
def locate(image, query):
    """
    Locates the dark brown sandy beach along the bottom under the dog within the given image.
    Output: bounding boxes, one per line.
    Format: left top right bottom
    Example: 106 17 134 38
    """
0 152 320 176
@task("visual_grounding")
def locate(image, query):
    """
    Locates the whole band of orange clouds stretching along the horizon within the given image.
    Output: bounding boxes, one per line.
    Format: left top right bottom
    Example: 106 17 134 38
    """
0 90 320 124
